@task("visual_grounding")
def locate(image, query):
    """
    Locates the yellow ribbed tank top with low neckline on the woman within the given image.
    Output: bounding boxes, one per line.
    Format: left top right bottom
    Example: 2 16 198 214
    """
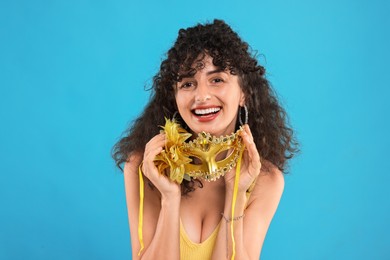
180 220 221 260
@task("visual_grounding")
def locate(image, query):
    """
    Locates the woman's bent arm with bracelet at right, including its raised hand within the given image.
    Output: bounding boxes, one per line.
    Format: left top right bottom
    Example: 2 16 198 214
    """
213 125 284 260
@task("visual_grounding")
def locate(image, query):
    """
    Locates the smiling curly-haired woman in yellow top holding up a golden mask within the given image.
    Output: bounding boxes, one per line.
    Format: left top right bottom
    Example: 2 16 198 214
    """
113 20 296 260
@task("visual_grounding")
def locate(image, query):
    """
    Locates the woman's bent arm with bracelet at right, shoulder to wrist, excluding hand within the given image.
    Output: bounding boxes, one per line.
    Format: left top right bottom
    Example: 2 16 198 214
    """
212 167 284 260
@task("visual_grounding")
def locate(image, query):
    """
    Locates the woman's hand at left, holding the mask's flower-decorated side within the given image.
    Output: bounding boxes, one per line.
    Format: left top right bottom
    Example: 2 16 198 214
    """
142 133 181 198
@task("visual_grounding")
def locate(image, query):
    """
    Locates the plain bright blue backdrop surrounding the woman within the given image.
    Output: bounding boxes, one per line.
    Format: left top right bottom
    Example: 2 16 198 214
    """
0 0 390 260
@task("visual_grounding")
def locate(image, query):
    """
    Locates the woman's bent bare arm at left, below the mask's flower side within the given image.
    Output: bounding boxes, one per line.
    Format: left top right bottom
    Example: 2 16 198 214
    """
124 137 181 260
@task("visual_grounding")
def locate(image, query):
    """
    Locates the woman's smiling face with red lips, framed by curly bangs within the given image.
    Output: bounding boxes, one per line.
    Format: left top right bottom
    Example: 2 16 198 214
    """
175 55 244 136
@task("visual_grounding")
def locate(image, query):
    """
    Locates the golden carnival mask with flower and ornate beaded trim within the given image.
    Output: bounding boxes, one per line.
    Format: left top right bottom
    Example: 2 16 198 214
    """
155 119 244 184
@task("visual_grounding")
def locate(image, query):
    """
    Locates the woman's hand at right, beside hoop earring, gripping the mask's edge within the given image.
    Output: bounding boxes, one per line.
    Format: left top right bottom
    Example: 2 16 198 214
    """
225 124 261 192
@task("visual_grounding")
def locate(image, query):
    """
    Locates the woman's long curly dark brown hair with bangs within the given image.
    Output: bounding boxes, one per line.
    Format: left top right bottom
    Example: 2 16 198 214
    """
112 20 298 194
